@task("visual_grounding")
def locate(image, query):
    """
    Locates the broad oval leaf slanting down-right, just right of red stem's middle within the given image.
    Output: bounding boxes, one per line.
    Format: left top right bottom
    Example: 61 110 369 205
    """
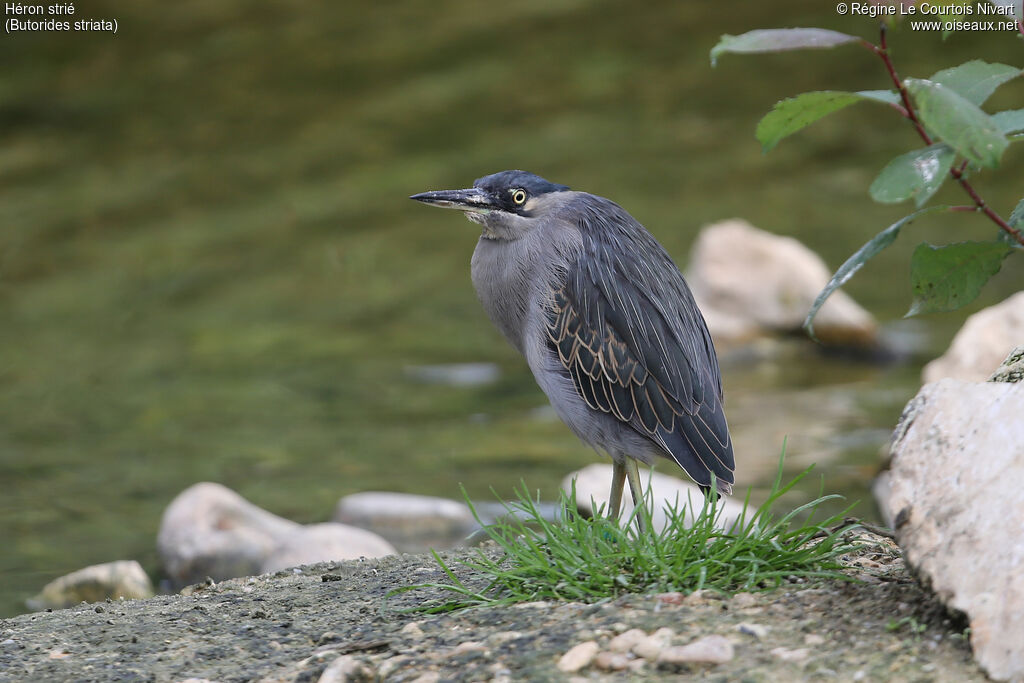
904 78 1010 168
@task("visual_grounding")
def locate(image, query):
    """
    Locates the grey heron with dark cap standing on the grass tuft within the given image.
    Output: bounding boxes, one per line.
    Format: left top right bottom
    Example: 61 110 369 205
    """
412 171 734 514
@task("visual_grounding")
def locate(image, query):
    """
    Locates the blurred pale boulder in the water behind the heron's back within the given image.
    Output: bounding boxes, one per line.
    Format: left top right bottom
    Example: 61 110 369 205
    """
687 219 878 347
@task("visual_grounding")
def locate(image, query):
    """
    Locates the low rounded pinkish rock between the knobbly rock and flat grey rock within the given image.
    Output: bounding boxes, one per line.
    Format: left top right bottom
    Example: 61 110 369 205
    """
260 522 397 573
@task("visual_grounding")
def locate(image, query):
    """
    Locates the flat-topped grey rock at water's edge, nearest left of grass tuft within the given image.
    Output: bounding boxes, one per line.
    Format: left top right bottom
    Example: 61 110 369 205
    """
334 492 478 553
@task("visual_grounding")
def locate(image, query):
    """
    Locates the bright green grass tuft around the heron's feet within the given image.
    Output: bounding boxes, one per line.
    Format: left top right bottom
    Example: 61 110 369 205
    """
390 456 856 613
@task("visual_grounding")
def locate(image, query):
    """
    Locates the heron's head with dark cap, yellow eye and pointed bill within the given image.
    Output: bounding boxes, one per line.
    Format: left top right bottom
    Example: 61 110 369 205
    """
410 171 568 240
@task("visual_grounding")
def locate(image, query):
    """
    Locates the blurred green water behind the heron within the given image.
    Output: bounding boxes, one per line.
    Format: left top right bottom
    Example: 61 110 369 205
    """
0 0 1024 615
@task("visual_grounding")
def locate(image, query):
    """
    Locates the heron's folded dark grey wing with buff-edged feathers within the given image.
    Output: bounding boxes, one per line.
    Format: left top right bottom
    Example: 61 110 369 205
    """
548 195 735 492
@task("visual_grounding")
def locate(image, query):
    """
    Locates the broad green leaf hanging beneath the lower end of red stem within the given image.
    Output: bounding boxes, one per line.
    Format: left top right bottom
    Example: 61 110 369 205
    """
904 242 1012 317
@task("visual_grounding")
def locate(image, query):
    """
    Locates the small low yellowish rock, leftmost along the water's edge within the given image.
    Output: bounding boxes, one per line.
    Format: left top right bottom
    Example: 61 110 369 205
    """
26 560 153 610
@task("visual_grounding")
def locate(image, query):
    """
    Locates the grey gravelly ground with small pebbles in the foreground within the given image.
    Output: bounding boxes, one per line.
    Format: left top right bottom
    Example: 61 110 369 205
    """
0 533 985 683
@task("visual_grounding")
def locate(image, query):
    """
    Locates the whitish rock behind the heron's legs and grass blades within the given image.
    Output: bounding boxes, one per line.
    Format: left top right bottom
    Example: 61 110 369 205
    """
561 464 743 531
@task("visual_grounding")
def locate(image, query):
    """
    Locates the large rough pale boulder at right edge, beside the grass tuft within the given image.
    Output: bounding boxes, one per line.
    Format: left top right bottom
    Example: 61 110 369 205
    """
878 356 1024 680
